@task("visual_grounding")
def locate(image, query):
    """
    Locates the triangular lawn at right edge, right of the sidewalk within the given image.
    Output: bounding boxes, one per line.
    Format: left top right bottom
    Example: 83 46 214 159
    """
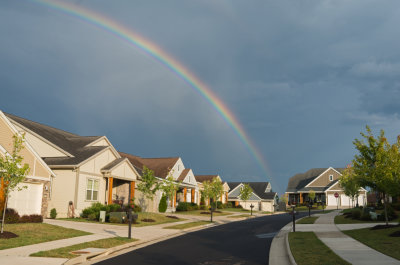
342 224 400 260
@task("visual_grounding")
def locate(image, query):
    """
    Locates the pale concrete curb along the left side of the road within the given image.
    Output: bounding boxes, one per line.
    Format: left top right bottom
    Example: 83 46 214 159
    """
63 223 222 265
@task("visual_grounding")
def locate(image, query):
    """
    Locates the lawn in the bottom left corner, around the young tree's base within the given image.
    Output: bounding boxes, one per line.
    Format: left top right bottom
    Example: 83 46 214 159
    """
0 223 90 249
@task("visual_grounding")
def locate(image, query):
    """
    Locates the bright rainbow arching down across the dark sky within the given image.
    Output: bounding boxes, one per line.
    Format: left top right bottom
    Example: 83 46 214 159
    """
30 0 271 186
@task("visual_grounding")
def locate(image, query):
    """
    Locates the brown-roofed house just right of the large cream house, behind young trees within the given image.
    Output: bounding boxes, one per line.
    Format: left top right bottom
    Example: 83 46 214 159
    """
119 152 200 212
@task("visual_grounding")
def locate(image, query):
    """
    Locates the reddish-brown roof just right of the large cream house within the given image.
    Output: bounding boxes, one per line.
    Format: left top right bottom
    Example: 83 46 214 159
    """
119 152 179 178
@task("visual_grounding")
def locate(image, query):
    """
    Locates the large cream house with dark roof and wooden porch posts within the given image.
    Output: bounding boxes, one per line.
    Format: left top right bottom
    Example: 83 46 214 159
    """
5 111 139 217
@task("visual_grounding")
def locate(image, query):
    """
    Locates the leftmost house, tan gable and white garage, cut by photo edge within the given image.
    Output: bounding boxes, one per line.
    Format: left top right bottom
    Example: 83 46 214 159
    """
0 111 55 217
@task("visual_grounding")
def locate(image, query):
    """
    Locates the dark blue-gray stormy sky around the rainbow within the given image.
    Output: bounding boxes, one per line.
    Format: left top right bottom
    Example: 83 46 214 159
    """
0 0 400 193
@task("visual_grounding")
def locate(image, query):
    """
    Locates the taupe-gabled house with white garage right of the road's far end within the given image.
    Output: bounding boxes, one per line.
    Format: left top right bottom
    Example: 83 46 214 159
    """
285 167 367 207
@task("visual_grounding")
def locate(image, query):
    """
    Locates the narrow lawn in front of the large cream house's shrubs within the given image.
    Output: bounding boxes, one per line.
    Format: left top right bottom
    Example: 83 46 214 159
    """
57 213 185 227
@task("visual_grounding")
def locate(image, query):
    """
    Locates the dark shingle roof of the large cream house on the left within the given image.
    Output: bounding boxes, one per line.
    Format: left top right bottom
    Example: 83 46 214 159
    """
4 113 107 166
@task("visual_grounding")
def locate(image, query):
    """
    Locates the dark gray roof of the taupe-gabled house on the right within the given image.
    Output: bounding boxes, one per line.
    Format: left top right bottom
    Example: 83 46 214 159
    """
286 168 344 192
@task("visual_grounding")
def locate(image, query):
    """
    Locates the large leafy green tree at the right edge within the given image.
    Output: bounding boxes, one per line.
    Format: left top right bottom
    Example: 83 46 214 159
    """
353 126 400 225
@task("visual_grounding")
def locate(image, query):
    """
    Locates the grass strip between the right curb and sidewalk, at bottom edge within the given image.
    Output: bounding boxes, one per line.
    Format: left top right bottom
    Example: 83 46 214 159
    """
289 232 350 265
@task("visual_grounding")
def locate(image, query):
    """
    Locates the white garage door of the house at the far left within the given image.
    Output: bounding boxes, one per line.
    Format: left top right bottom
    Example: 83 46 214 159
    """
8 183 43 216
